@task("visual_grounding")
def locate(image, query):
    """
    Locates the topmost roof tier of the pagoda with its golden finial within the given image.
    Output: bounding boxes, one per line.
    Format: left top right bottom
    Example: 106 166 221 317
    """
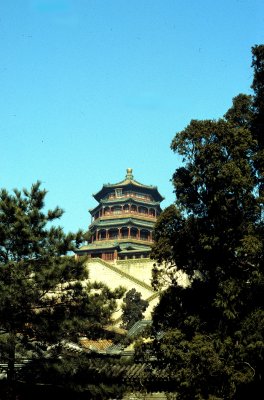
93 168 164 202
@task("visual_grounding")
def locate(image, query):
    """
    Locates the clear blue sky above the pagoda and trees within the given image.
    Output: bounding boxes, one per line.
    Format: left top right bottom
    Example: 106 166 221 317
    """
0 0 264 231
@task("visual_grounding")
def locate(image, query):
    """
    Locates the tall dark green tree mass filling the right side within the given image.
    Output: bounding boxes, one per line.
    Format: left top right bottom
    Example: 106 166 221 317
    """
144 46 264 400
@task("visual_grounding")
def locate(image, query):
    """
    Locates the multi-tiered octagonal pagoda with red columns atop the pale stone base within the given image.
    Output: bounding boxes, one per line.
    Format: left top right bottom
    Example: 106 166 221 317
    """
76 168 164 262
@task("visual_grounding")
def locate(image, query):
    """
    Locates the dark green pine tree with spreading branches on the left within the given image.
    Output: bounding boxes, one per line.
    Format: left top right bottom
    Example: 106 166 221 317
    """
0 182 123 390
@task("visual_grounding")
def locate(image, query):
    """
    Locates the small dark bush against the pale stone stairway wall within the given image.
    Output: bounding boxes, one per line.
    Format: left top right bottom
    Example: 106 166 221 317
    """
122 289 148 329
